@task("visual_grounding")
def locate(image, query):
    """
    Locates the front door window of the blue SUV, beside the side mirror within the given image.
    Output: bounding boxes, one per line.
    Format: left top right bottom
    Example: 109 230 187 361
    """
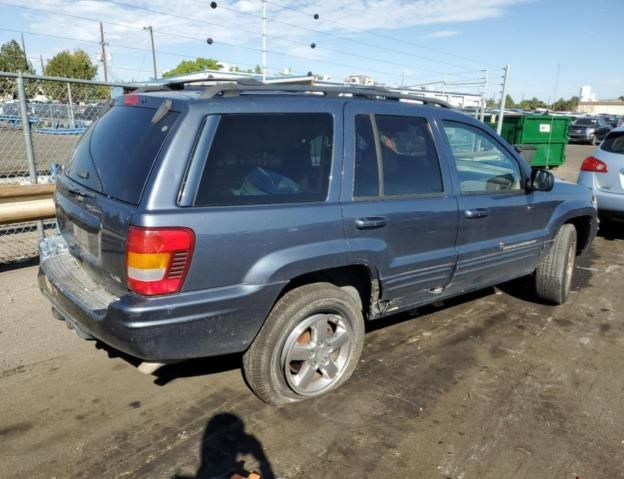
444 121 523 194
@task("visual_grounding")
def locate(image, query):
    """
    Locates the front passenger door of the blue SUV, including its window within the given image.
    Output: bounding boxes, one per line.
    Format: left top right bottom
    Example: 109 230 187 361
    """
438 117 551 292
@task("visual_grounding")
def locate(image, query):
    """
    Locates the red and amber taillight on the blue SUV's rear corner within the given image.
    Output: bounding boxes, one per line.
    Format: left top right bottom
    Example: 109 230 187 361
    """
126 226 195 295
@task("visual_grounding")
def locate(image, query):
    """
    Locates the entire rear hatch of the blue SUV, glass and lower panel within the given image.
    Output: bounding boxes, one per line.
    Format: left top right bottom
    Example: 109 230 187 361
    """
56 95 180 292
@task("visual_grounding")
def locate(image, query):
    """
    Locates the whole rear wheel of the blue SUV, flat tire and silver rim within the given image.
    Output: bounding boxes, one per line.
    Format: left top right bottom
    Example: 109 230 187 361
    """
243 283 364 405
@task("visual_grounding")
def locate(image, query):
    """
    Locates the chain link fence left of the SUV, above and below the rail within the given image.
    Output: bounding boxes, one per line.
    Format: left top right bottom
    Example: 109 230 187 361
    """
0 73 132 265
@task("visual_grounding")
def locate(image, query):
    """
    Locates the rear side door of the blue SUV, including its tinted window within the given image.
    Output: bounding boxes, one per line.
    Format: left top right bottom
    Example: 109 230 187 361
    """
342 101 457 309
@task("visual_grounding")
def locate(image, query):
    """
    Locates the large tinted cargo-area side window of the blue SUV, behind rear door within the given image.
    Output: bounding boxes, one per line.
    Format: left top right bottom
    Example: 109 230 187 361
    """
195 113 333 206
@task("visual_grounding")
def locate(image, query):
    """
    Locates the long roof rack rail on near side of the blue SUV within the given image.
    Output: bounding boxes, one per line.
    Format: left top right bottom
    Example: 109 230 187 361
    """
193 80 452 108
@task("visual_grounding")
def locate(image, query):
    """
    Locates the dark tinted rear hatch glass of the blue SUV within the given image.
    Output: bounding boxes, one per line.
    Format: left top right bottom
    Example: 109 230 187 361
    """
67 106 178 205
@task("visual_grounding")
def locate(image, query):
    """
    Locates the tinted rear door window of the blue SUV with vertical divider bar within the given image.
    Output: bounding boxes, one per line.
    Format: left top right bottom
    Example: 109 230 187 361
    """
353 115 443 198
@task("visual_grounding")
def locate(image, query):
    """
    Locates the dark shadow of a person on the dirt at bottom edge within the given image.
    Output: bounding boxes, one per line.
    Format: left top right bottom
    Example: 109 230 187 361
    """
173 413 275 479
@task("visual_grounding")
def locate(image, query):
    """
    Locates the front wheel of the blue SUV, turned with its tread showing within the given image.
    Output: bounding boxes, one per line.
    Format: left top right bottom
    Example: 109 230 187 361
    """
535 224 576 304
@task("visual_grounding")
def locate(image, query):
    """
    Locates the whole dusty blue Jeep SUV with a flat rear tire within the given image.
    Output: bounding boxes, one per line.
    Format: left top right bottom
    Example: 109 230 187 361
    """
39 84 597 404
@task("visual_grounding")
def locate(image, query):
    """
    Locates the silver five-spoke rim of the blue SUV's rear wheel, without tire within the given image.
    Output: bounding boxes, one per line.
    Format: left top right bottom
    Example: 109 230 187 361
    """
281 313 354 396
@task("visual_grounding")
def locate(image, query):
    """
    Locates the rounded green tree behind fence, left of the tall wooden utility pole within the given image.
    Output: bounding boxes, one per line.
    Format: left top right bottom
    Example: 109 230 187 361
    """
43 49 105 103
